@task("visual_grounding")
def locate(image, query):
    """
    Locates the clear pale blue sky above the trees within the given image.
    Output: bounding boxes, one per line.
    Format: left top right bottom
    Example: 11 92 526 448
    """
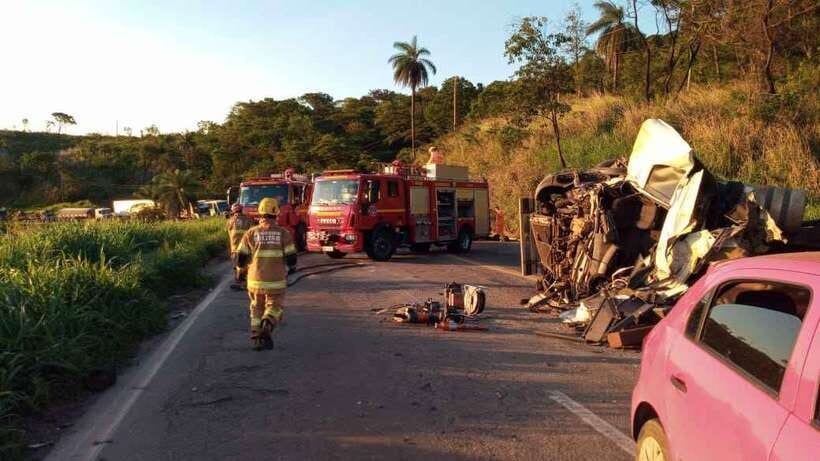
0 0 655 134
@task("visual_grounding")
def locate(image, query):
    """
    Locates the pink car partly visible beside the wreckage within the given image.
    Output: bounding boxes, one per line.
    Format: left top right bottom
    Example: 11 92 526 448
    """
632 252 820 461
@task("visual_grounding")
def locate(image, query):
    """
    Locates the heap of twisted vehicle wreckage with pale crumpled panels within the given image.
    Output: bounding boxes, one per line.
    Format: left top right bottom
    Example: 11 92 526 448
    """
521 119 820 347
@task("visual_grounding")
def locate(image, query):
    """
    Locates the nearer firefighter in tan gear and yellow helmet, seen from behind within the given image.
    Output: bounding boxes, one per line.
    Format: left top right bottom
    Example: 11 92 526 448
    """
238 198 296 350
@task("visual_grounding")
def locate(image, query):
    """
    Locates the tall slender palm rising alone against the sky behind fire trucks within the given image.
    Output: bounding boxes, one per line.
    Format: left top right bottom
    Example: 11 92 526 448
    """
387 35 436 160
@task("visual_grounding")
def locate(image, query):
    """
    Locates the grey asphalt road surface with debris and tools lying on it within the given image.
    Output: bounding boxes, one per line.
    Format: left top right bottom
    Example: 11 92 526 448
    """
49 242 639 460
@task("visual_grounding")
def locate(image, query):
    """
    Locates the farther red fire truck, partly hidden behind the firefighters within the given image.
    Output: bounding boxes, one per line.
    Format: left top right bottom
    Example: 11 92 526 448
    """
228 169 313 251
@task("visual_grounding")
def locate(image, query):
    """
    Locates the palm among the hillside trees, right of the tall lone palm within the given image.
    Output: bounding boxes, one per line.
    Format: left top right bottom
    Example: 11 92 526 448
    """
587 2 635 92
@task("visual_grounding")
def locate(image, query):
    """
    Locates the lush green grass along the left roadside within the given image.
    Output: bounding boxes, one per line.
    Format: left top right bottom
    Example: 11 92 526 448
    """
0 219 226 459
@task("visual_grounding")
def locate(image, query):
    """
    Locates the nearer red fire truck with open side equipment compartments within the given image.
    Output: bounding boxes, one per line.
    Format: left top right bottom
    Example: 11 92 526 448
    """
307 162 490 261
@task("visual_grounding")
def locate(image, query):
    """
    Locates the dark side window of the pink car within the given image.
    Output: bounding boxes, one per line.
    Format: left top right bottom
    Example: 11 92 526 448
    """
687 281 811 393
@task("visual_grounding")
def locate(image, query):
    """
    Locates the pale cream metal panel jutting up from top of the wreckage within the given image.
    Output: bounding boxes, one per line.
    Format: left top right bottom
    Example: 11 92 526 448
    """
626 119 695 207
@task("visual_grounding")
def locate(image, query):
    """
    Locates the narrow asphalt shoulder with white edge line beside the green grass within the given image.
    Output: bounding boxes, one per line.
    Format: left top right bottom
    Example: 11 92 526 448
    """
46 274 233 461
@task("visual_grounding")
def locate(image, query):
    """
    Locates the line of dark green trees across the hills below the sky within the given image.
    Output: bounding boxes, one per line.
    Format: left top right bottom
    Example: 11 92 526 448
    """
0 0 820 206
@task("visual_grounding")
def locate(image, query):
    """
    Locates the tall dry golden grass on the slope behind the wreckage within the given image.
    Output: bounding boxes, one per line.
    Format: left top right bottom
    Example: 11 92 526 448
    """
437 84 820 231
